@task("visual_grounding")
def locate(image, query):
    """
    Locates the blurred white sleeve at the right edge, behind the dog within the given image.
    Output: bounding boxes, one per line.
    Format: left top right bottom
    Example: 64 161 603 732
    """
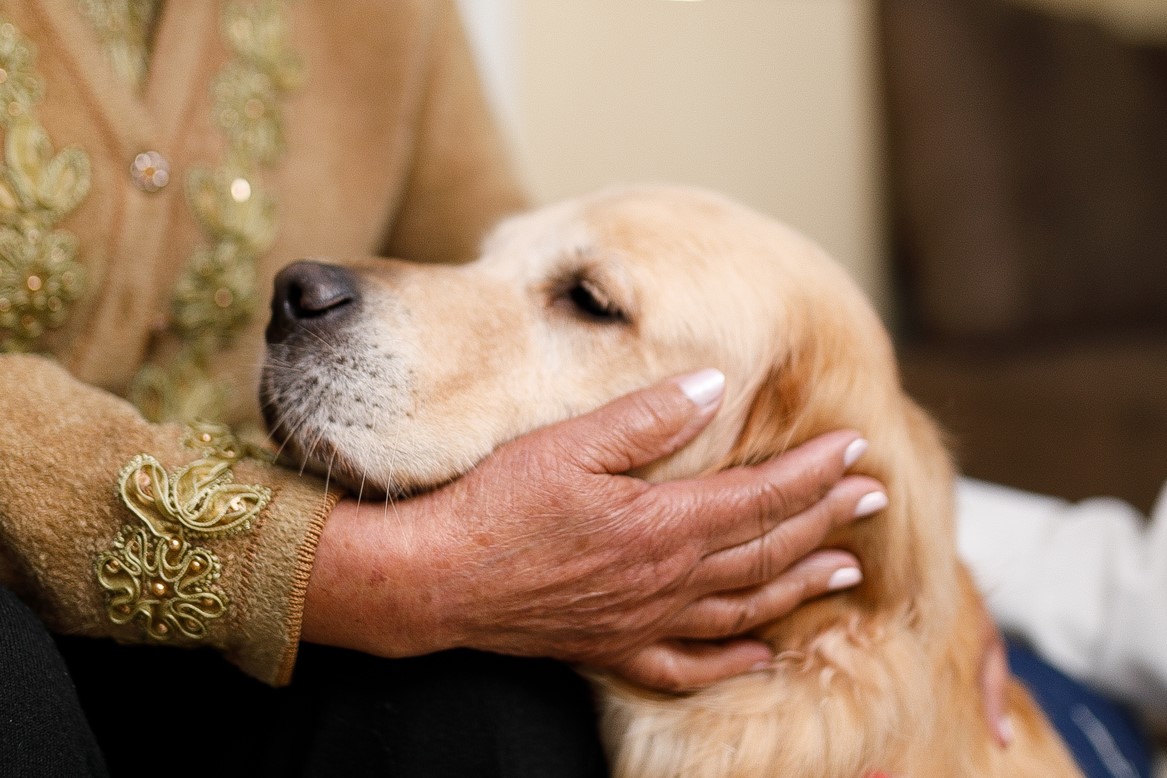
957 479 1167 716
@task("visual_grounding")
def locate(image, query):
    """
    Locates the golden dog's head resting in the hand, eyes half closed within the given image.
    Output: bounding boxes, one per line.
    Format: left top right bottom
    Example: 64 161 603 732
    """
261 188 944 601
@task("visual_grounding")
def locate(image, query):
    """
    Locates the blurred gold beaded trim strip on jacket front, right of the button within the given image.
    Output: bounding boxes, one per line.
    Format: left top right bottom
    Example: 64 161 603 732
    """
132 0 303 421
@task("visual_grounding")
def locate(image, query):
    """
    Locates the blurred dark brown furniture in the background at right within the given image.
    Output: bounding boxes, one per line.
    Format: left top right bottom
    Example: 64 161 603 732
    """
880 0 1167 509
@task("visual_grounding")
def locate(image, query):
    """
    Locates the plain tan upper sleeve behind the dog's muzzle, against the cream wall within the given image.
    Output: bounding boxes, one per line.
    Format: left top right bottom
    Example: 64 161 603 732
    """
382 0 529 262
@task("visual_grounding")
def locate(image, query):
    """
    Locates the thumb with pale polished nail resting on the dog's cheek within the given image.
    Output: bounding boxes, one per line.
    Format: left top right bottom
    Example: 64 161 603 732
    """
543 367 726 474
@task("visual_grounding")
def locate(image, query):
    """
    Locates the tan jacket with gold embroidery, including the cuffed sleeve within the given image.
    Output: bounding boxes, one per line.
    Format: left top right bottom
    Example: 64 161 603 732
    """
0 0 524 684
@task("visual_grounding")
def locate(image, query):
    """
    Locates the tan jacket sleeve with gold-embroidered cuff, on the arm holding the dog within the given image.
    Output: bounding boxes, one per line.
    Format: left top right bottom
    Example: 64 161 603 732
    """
0 355 338 685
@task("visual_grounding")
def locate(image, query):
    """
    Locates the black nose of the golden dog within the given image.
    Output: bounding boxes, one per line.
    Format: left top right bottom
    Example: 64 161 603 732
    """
266 260 359 343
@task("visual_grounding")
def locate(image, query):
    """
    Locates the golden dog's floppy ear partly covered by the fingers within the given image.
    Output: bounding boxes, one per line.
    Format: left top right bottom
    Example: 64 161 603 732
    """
722 295 955 615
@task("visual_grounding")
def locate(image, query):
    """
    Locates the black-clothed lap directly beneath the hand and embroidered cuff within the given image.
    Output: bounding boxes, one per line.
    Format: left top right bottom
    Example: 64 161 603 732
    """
60 638 607 778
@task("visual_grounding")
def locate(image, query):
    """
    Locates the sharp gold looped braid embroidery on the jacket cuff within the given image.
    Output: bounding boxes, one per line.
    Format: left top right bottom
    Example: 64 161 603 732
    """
97 425 272 642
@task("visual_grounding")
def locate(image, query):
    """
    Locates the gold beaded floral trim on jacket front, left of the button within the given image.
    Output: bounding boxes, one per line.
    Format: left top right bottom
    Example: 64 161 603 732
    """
0 17 90 351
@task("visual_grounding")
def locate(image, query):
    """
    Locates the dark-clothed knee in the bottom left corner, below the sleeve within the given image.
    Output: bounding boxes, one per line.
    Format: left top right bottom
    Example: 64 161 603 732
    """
0 587 105 778
